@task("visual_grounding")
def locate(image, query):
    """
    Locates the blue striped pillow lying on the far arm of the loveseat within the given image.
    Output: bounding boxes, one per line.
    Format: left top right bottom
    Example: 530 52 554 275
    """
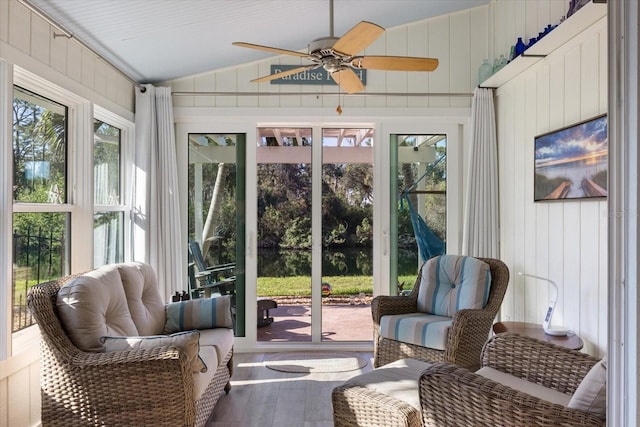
164 295 233 334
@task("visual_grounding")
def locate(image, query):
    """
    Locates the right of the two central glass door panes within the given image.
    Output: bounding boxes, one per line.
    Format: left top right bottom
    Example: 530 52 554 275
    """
322 128 373 342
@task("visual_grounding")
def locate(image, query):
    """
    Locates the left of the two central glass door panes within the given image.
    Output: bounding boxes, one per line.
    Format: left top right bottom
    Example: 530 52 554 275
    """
256 127 312 342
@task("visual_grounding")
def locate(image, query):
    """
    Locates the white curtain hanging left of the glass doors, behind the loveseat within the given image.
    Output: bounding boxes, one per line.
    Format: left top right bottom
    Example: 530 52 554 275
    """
132 85 187 301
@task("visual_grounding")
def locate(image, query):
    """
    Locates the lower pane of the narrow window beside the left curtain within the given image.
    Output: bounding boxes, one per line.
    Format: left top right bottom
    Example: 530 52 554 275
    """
93 212 124 268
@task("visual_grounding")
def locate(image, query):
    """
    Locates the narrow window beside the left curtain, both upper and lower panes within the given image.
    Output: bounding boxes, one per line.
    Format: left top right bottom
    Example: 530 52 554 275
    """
93 119 125 267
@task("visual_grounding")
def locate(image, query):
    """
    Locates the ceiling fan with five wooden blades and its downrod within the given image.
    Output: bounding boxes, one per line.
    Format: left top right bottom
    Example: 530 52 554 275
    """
232 0 438 93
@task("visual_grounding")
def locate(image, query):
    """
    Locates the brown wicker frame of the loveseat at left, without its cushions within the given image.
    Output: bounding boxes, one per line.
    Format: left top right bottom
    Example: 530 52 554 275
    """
27 275 232 427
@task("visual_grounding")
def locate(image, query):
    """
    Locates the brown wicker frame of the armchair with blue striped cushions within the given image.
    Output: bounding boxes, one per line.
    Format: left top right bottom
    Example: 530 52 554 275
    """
371 258 509 371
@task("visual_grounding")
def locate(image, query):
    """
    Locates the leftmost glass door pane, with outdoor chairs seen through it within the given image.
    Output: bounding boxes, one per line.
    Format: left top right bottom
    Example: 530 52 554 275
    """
188 133 246 336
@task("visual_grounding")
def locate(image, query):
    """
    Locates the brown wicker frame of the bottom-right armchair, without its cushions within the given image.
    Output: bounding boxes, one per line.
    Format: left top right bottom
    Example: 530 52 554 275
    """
419 332 606 427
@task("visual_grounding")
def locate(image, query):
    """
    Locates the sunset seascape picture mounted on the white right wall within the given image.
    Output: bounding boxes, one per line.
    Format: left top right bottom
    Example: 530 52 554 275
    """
533 114 609 202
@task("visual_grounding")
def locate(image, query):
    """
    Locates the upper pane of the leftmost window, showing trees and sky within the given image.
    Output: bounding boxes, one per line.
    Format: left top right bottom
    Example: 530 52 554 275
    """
13 87 67 203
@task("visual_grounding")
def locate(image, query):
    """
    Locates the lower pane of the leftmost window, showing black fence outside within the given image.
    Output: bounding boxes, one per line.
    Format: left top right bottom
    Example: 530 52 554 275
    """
12 213 70 332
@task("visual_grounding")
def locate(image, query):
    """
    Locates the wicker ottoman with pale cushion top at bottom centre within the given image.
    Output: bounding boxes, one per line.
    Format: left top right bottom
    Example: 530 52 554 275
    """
331 359 430 427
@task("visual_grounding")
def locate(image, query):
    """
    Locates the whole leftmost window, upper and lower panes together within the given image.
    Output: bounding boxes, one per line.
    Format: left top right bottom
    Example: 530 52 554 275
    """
11 86 70 332
